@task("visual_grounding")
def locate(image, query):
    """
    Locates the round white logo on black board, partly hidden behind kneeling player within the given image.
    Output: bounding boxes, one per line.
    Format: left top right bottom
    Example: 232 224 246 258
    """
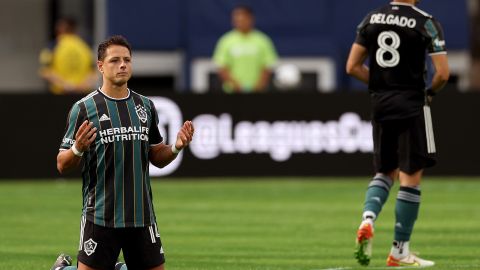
150 97 183 176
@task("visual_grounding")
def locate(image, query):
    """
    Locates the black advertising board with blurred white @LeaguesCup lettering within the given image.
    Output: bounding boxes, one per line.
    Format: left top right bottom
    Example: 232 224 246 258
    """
0 91 480 178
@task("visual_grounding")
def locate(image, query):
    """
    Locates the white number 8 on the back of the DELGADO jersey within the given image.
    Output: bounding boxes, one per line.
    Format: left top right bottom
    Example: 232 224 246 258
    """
376 31 400 68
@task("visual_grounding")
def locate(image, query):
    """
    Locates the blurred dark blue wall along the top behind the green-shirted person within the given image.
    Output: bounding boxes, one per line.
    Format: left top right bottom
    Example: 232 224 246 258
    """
107 0 469 87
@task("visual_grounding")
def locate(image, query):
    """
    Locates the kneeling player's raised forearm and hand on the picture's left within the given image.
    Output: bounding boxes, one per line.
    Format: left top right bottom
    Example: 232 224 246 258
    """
57 120 97 174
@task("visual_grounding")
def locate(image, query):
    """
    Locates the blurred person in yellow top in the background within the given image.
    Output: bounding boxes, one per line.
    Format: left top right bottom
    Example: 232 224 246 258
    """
39 17 97 95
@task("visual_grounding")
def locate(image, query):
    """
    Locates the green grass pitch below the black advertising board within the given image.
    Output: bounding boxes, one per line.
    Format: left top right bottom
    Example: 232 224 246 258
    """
0 177 480 270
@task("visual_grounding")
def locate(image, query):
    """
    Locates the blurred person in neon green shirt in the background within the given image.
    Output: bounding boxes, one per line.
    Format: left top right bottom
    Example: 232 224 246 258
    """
213 5 278 93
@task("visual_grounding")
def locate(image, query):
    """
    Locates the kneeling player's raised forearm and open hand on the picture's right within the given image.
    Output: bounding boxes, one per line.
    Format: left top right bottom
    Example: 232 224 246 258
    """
148 121 195 168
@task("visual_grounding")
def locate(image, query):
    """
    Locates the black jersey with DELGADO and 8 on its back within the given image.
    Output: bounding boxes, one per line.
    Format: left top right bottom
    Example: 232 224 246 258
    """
355 2 446 120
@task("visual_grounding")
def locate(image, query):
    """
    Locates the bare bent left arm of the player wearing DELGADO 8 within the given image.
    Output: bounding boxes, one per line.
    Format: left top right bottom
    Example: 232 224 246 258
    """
346 43 370 84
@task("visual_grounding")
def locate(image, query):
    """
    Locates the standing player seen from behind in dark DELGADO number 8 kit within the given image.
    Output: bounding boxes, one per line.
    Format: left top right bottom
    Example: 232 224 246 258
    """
346 0 449 266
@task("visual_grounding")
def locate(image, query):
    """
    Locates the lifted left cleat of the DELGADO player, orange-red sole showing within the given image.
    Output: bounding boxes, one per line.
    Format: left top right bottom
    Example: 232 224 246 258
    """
354 219 373 266
